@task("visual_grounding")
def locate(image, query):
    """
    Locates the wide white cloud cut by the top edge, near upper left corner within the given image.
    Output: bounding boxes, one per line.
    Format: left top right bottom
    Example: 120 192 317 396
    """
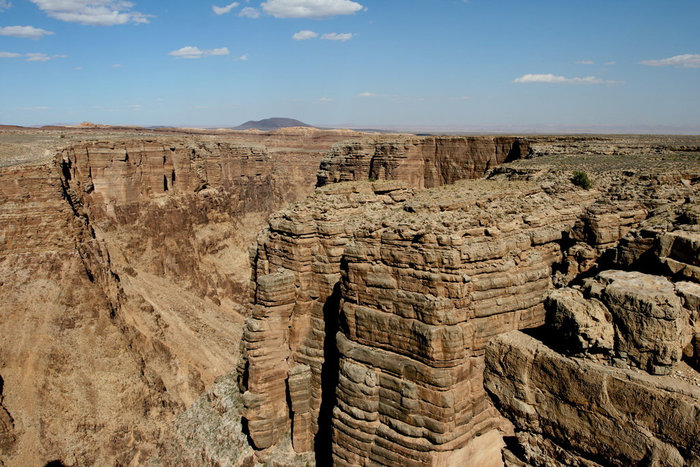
31 0 150 26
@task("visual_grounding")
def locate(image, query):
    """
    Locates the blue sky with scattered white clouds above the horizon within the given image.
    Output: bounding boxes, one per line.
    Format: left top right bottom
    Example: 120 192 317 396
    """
0 0 700 133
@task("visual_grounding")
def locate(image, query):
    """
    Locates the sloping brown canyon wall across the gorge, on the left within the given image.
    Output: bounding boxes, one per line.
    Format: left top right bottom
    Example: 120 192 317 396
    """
0 137 336 465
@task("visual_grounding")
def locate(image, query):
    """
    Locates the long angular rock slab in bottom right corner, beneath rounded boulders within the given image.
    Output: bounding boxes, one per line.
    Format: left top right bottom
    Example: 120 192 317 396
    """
485 332 700 467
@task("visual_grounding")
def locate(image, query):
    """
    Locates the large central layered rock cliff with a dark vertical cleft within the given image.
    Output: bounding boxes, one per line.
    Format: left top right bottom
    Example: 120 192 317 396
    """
243 177 595 465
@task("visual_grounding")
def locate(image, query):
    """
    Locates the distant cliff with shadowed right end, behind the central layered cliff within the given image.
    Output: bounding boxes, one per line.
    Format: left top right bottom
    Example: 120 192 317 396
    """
317 136 529 188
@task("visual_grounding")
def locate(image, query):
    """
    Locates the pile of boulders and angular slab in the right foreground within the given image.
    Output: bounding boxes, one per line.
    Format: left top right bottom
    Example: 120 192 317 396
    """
484 178 700 466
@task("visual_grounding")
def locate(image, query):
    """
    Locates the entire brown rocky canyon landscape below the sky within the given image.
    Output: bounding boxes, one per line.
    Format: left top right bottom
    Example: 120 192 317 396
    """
0 126 700 466
